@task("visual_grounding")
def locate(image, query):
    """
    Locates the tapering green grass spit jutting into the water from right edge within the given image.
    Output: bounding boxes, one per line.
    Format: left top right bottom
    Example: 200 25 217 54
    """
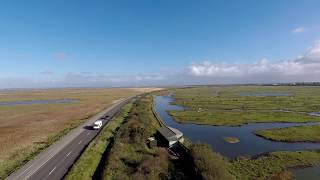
255 125 320 142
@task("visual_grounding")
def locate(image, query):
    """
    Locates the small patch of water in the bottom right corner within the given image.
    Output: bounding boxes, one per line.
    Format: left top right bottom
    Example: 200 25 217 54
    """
292 166 320 180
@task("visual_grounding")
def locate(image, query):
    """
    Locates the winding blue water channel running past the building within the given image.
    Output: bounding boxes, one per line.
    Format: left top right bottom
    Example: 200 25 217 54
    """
155 96 320 158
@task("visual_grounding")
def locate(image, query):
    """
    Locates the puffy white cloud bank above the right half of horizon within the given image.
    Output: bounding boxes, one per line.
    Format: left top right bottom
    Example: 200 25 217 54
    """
188 42 320 82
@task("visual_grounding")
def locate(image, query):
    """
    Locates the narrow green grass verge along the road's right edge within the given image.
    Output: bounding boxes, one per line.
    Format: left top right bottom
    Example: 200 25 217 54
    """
66 104 132 180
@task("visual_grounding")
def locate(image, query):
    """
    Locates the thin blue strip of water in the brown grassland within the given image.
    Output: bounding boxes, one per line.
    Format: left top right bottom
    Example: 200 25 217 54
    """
0 99 79 106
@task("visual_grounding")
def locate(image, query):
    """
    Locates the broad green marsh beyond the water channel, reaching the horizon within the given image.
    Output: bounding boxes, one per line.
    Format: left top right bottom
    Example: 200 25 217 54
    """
169 86 320 126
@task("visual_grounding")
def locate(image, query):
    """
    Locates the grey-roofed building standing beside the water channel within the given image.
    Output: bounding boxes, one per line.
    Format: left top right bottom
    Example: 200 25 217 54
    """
157 126 184 147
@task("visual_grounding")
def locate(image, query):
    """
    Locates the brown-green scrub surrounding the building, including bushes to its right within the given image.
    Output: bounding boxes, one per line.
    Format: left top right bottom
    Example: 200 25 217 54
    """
103 96 238 180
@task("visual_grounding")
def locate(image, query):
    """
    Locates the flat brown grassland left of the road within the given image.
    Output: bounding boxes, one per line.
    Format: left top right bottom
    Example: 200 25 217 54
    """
0 89 140 179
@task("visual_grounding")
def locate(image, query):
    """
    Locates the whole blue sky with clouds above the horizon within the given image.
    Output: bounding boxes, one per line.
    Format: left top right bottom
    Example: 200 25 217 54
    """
0 0 320 88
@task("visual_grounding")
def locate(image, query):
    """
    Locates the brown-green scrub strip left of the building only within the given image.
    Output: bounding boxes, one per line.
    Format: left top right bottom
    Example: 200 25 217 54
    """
103 95 180 180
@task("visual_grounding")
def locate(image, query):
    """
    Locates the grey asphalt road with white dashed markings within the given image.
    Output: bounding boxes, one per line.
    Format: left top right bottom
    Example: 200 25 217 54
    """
8 97 133 180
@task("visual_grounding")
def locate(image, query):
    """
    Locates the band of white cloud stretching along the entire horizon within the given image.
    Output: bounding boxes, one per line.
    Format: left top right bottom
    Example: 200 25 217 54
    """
0 41 320 89
